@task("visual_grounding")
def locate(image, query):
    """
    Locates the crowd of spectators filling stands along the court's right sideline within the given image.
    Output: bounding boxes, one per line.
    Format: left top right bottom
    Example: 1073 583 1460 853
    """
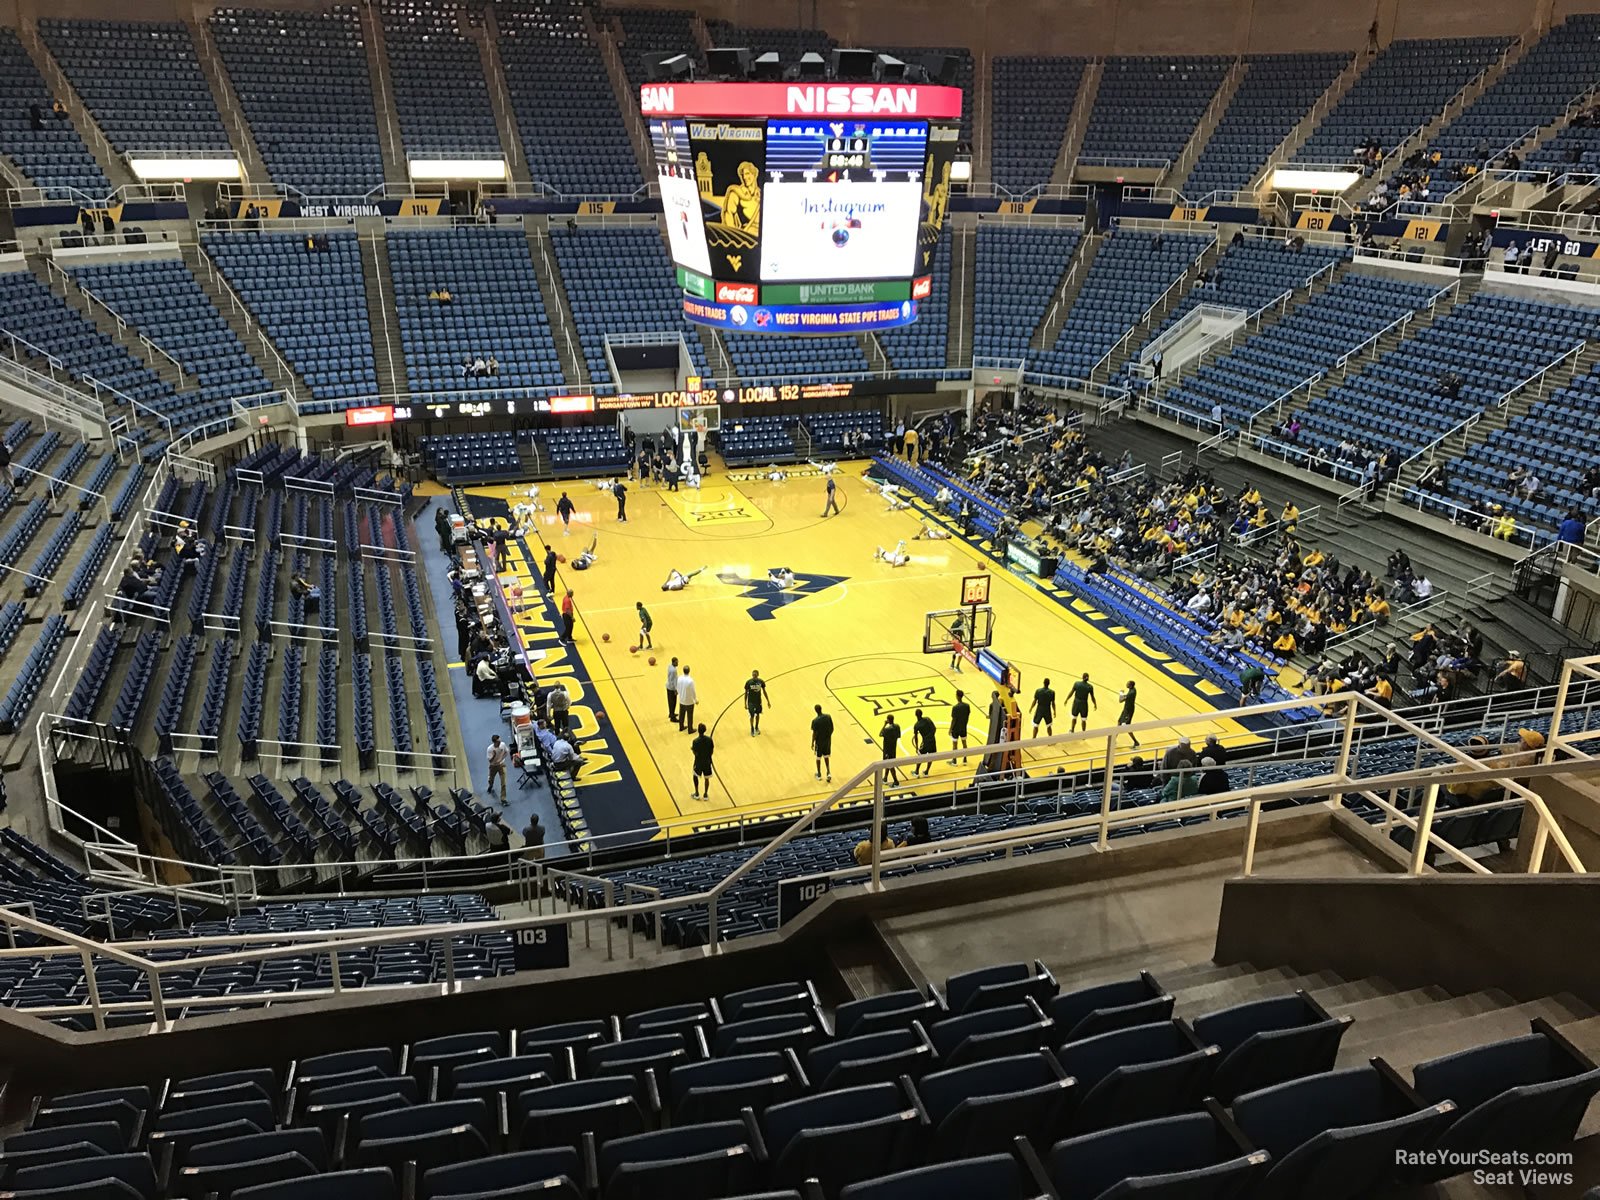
946 392 1548 713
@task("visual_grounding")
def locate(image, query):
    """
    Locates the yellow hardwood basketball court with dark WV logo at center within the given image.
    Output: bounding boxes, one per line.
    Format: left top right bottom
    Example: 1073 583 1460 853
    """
454 464 1256 829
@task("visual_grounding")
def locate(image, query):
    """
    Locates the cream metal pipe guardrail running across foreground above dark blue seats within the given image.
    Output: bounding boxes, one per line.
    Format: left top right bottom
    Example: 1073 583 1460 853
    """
18 678 1600 1030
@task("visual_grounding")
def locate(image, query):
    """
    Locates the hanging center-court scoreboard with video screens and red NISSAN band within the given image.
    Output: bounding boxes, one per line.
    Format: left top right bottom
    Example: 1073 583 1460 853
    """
640 83 962 334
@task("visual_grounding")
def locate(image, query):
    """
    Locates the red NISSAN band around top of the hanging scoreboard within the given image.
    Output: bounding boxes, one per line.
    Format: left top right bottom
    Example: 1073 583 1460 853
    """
638 83 962 120
